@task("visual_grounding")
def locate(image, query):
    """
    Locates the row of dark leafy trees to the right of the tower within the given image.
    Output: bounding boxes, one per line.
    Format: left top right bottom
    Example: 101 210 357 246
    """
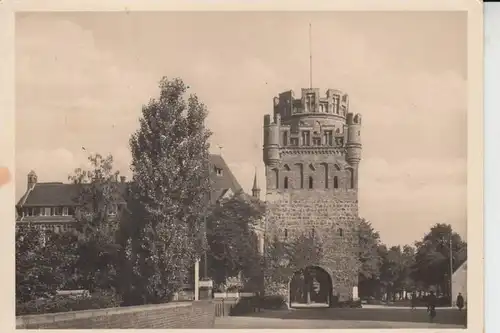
359 221 467 297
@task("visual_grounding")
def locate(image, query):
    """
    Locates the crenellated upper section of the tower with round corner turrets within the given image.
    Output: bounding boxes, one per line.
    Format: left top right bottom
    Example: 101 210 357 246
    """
264 88 362 187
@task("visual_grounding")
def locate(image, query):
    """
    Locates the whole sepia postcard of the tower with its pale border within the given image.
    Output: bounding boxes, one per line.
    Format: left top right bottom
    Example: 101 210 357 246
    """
2 1 483 331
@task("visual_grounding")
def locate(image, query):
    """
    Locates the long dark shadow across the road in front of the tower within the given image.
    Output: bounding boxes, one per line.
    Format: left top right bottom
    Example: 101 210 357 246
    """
240 308 467 328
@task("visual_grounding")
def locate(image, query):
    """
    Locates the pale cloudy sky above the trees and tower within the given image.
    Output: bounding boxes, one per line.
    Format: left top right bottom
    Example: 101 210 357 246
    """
15 12 467 245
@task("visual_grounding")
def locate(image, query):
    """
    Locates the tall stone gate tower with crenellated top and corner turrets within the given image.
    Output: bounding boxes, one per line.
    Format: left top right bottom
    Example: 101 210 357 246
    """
263 88 362 300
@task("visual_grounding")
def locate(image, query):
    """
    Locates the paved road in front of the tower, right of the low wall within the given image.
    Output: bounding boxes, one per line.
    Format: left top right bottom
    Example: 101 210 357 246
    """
215 308 466 329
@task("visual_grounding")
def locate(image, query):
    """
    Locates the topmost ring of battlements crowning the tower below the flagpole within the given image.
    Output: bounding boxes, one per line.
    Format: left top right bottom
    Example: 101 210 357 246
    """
274 88 349 120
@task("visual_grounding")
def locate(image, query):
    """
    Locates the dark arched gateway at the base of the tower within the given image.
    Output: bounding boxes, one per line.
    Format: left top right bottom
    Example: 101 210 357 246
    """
288 266 333 307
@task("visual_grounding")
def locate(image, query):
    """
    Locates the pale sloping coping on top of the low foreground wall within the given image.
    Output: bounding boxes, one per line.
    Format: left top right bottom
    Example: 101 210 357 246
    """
16 300 207 328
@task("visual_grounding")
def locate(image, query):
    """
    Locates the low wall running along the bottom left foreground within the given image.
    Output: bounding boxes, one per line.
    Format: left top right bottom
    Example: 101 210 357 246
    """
16 301 215 329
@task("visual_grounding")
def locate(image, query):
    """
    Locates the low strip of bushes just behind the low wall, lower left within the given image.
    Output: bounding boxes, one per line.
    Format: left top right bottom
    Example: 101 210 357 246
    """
16 293 121 316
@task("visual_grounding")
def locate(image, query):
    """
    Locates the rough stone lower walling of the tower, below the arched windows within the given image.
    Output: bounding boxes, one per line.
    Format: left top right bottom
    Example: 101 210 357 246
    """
266 188 359 300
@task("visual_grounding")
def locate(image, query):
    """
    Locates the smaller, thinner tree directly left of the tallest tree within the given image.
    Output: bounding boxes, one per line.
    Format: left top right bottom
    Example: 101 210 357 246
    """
69 154 123 292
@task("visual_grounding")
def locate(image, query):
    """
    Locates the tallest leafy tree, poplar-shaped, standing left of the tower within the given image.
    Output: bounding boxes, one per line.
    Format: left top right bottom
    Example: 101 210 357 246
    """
130 78 211 302
